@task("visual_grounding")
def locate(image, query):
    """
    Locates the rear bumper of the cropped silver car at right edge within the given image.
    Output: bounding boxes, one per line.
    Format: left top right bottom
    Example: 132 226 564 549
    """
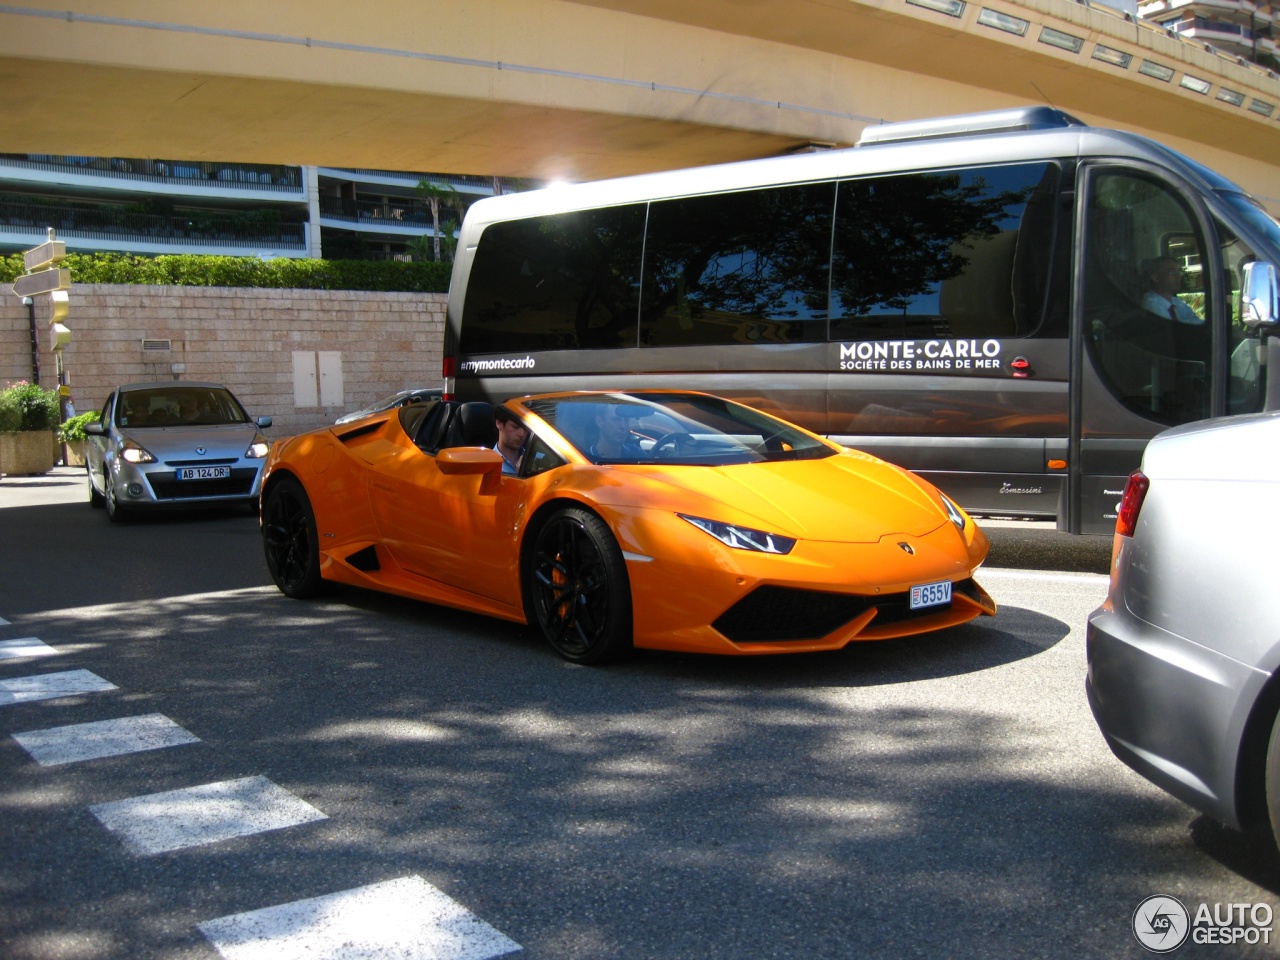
1085 607 1267 828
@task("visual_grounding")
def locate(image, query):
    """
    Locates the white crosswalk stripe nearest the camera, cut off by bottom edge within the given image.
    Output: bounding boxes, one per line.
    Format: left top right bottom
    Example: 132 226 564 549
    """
198 877 522 960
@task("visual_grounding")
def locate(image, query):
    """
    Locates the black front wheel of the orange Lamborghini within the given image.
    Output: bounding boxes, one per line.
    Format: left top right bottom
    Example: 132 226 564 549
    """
525 507 632 663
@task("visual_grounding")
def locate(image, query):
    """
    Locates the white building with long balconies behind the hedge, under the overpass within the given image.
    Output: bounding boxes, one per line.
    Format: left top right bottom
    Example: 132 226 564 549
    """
0 154 500 260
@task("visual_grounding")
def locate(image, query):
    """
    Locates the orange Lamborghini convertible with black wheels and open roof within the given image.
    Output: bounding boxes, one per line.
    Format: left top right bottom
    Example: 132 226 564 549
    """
261 390 996 663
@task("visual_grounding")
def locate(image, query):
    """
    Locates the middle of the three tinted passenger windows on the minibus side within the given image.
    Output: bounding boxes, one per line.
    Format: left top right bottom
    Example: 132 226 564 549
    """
640 183 835 347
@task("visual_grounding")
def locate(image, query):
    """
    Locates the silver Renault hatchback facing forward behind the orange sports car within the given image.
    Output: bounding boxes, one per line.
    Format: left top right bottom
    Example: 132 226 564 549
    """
84 380 271 521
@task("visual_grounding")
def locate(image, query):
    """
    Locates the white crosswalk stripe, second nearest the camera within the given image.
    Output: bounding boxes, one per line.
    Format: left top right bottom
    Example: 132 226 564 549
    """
88 777 329 856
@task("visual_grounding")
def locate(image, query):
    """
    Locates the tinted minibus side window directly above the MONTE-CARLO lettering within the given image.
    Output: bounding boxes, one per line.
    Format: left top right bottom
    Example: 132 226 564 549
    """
831 163 1059 340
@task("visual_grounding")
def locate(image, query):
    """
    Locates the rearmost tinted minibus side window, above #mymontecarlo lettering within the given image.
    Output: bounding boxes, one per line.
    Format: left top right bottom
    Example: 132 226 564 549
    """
460 204 645 353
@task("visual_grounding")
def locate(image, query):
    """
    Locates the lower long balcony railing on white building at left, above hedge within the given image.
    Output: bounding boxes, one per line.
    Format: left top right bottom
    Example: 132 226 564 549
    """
0 200 306 250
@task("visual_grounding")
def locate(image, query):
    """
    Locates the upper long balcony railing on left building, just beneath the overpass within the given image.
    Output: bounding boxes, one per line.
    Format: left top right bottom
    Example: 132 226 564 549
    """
0 154 302 193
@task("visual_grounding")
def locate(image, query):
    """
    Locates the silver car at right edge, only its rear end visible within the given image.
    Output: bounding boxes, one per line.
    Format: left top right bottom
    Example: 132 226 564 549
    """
1085 413 1280 837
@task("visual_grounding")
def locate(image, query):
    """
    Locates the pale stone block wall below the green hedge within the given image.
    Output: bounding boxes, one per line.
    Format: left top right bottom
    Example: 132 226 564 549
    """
0 284 447 438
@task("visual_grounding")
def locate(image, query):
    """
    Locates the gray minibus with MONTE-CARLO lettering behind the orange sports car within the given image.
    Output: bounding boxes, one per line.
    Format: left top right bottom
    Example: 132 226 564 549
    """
444 108 1280 534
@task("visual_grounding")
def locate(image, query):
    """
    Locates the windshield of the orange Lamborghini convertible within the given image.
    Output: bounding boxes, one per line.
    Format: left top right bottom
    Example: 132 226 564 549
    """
526 393 836 466
